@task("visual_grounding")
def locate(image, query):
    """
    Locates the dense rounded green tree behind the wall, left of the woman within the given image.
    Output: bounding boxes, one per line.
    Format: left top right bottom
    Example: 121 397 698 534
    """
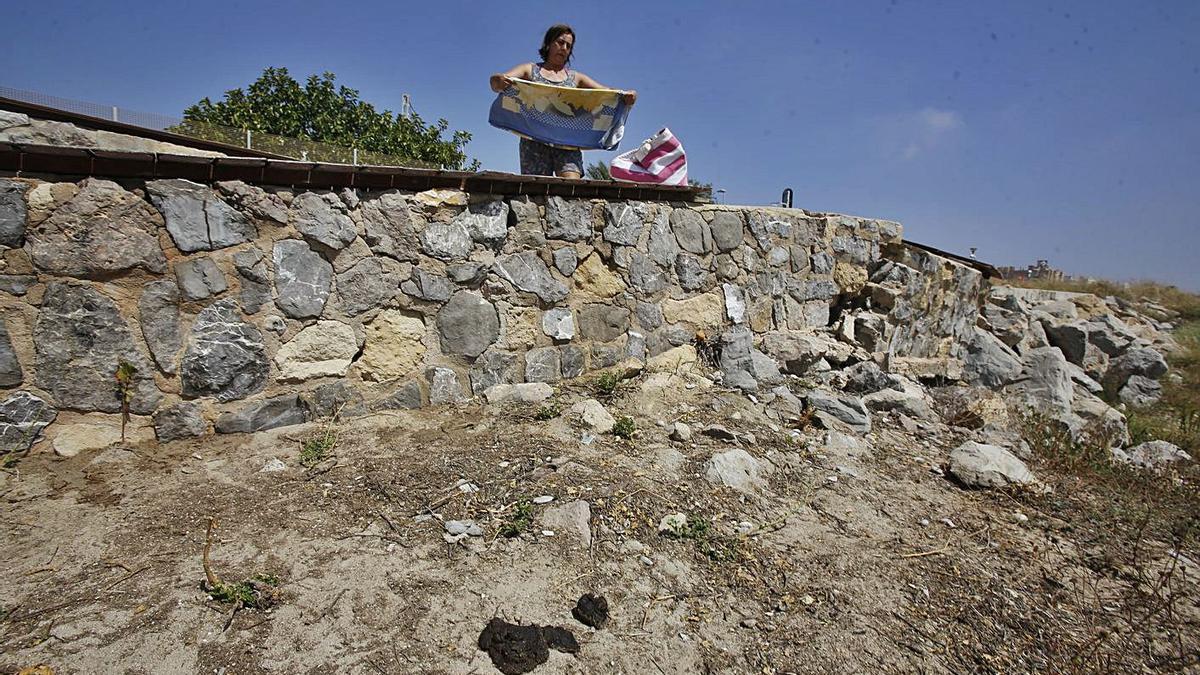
177 67 479 171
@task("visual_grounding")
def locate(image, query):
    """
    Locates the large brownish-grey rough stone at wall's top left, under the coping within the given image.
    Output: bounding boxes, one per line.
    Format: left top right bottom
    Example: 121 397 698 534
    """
25 178 167 279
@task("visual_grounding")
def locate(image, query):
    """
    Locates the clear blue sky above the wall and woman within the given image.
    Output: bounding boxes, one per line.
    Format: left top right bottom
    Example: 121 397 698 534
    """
0 0 1200 289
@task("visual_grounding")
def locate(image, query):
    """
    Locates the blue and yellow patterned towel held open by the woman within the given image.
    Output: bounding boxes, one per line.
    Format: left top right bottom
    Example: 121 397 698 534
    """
487 79 629 150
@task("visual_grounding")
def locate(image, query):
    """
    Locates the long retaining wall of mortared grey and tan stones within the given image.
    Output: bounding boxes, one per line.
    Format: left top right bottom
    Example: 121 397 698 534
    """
0 172 980 453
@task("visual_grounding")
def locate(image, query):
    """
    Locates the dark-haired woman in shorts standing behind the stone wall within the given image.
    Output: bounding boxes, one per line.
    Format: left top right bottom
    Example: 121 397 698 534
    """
491 24 637 178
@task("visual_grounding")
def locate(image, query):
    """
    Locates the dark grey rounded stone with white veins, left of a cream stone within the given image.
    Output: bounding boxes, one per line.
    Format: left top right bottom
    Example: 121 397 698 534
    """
180 297 270 402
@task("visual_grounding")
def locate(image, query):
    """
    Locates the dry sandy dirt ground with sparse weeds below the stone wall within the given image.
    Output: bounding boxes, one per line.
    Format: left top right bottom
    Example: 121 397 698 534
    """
0 369 1200 674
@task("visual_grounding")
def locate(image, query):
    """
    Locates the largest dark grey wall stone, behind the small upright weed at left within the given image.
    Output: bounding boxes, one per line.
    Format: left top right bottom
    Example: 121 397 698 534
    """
34 282 162 414
